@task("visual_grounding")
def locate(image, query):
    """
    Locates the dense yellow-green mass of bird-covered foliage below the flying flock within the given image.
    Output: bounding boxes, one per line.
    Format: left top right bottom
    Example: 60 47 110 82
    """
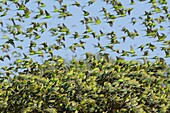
0 54 170 113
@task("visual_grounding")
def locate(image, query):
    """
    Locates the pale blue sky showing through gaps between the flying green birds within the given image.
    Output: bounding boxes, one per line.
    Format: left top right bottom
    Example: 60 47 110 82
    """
0 0 170 66
